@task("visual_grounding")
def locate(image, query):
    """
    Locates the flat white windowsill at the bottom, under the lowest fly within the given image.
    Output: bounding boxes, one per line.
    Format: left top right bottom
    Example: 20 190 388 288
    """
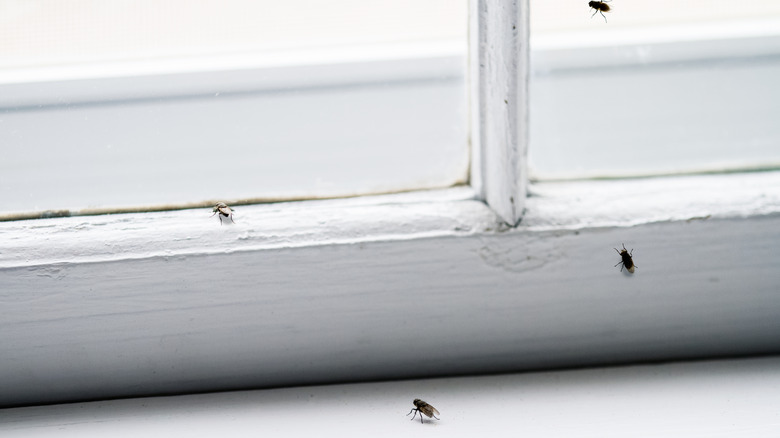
0 357 780 438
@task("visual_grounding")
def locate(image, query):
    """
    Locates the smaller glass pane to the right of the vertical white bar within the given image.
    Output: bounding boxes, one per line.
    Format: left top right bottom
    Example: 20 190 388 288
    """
529 0 780 179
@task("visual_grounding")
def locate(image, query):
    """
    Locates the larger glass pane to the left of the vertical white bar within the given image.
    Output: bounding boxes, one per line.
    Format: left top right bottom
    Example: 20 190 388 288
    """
0 0 468 215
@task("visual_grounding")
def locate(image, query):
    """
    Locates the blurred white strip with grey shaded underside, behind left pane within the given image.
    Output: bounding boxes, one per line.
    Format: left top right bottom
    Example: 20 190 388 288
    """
0 41 466 111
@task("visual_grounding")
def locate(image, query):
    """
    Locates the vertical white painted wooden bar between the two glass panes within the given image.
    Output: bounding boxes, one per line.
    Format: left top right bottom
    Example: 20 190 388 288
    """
469 0 529 225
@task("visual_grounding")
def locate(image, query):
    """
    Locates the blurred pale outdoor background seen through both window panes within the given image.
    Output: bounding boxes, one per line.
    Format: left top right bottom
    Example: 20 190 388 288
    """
0 0 780 216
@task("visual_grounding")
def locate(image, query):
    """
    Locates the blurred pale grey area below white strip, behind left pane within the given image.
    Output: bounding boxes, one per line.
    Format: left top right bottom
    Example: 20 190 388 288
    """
0 53 469 218
